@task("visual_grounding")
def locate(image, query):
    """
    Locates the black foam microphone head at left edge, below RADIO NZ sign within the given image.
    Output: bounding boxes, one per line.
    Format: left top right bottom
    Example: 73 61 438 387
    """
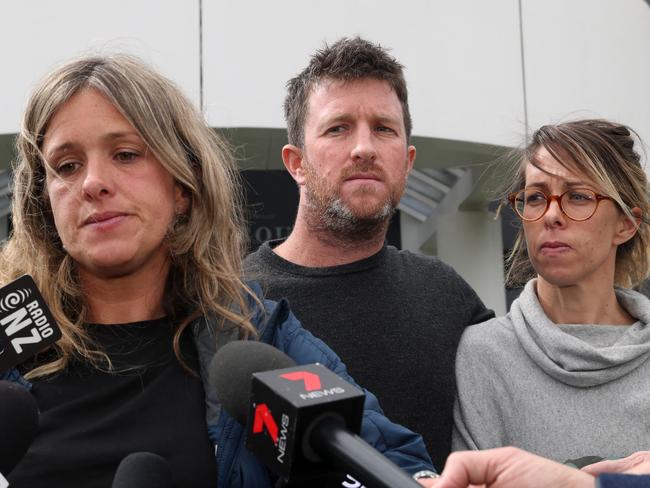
0 381 38 476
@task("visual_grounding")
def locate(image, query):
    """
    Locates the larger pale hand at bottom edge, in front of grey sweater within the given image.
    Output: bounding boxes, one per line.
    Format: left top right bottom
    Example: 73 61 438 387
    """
425 447 595 488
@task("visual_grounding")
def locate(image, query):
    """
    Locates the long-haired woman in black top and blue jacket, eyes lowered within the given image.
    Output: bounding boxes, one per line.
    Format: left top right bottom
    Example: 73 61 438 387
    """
0 56 430 488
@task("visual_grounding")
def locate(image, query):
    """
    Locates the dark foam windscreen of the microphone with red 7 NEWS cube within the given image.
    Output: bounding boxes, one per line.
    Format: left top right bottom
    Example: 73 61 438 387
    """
210 341 296 425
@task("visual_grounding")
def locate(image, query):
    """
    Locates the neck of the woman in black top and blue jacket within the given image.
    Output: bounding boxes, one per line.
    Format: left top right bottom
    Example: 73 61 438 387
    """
80 263 169 324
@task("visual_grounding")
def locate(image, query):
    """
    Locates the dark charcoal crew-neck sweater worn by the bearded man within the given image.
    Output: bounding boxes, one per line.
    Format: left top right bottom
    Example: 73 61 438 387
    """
245 241 494 469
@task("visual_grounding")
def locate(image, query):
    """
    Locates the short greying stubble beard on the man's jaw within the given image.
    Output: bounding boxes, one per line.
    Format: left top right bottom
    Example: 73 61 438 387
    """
302 161 404 242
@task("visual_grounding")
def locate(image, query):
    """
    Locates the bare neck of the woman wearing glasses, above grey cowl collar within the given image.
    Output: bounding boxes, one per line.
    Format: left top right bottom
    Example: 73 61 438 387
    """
536 277 635 325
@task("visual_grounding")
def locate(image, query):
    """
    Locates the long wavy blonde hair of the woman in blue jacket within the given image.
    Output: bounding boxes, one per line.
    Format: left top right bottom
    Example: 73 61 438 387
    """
0 55 255 377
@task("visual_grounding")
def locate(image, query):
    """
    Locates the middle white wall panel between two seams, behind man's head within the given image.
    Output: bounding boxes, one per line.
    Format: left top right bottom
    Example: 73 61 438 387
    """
204 0 524 144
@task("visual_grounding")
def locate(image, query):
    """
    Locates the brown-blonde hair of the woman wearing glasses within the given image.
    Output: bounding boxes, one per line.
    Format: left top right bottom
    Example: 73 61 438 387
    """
502 119 650 287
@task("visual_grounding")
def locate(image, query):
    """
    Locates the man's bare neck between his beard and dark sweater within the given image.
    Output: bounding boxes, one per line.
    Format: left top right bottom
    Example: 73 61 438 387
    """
273 220 386 268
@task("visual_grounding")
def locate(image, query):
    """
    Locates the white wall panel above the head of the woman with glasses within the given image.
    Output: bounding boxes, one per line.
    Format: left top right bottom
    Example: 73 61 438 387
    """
522 0 650 150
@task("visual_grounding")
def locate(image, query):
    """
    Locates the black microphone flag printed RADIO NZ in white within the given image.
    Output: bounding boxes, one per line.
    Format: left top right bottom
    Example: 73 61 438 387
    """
0 275 61 372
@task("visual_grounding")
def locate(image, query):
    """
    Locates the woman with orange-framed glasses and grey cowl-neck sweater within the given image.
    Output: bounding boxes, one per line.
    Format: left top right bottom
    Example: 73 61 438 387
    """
453 120 650 466
